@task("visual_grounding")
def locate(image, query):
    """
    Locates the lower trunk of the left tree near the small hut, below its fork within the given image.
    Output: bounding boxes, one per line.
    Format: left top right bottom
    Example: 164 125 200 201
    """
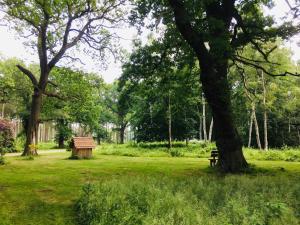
22 88 42 156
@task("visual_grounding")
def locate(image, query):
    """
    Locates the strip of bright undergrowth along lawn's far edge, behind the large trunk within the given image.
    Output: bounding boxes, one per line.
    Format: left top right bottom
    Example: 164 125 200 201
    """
97 142 300 162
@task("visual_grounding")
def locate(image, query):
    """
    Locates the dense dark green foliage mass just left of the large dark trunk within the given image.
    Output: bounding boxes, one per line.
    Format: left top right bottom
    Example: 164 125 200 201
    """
119 41 201 142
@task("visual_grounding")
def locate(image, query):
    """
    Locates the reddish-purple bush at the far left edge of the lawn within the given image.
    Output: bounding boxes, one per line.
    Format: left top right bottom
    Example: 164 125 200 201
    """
0 119 15 155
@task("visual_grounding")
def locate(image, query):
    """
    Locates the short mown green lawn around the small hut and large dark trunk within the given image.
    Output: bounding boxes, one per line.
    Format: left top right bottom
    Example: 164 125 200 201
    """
0 147 300 225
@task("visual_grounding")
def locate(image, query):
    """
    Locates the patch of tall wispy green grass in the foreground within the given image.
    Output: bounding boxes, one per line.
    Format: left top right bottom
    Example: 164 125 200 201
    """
76 175 300 225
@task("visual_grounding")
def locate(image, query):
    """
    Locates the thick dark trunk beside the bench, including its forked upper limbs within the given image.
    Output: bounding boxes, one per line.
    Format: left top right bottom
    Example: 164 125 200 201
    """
169 0 248 172
